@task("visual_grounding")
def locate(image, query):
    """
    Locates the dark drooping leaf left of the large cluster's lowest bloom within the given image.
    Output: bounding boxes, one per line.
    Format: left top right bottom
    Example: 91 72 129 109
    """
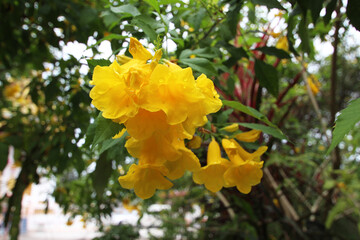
91 154 112 197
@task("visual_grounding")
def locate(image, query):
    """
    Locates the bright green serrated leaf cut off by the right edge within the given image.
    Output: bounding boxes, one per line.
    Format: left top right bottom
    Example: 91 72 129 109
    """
326 98 360 154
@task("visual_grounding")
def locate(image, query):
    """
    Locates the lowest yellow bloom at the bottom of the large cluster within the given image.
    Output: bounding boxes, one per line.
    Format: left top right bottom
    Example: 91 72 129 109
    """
119 164 173 199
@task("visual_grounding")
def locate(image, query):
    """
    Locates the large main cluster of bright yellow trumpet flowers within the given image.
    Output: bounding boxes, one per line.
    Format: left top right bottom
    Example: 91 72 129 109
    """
90 38 222 199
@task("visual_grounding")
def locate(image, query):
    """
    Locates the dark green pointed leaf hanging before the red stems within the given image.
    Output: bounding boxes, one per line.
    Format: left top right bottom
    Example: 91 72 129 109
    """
255 59 279 97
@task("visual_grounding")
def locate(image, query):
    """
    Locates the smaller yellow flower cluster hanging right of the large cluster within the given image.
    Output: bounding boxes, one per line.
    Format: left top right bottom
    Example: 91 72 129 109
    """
193 129 267 194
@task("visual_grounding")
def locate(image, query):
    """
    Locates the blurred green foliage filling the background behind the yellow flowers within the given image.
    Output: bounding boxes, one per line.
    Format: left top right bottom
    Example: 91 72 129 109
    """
0 0 360 239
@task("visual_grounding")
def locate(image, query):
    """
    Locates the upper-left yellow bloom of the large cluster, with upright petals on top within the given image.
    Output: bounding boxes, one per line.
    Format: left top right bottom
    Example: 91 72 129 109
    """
90 38 161 123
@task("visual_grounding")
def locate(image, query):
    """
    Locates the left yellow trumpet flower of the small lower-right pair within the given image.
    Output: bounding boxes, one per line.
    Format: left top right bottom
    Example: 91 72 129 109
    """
193 139 230 192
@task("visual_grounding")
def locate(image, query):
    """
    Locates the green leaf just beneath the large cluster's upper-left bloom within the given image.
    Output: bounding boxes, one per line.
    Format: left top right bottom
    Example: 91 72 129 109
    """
92 113 124 147
